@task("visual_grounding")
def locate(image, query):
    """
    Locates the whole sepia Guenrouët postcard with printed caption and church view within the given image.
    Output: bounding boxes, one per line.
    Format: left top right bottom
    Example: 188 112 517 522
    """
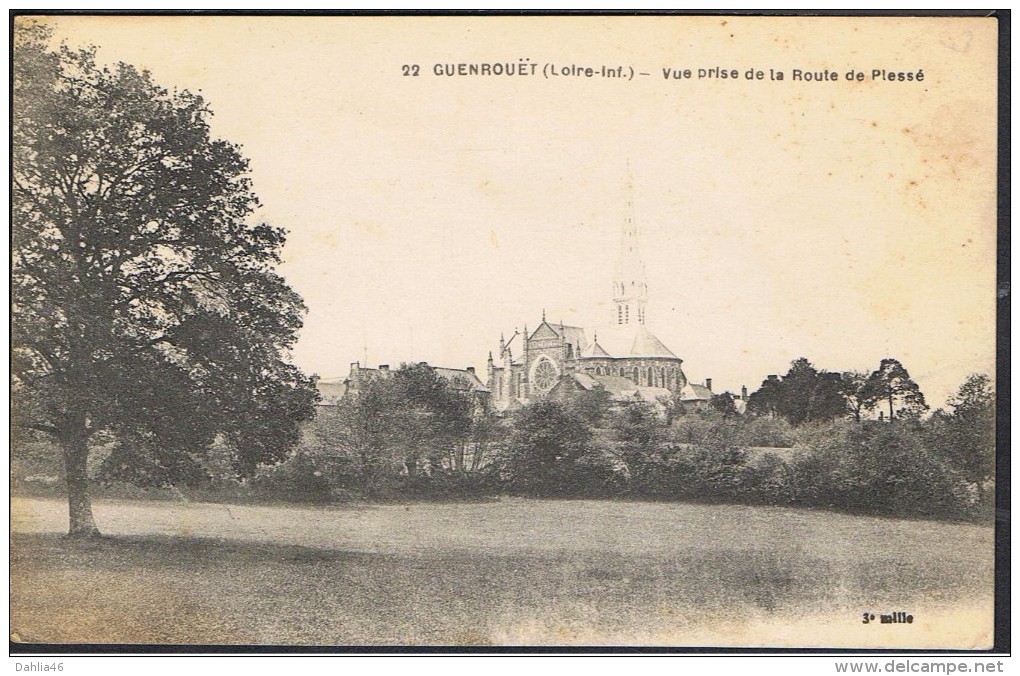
10 14 999 651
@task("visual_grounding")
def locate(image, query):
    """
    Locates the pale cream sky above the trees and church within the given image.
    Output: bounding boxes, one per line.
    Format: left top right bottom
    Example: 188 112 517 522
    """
37 16 997 407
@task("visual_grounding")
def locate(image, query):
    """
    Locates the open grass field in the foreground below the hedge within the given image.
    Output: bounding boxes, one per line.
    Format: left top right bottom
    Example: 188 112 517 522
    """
11 499 992 647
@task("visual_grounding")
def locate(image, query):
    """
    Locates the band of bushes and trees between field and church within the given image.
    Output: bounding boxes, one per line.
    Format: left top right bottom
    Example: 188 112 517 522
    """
242 359 995 519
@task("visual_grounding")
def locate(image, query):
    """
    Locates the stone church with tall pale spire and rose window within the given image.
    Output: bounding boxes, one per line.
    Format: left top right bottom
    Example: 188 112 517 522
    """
487 190 711 411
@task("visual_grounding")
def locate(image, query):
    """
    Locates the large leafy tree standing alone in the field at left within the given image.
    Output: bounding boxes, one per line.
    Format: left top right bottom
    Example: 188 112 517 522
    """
11 22 316 536
